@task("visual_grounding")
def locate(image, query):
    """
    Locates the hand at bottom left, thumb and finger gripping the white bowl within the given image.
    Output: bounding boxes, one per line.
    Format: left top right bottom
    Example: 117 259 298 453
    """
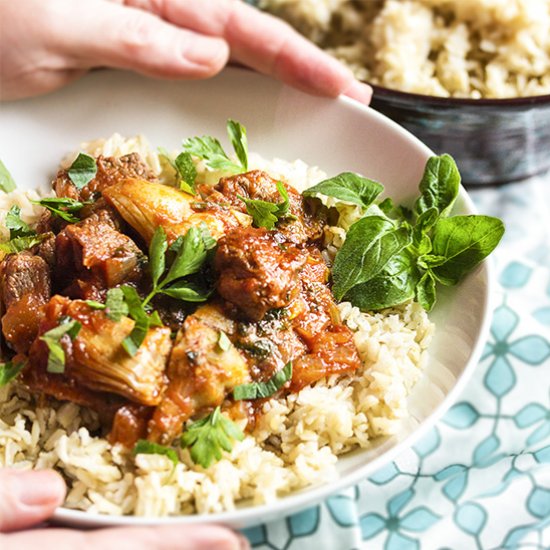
0 469 249 550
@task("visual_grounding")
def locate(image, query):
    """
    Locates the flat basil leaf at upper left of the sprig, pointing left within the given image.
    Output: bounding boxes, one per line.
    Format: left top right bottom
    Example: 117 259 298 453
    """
302 172 384 208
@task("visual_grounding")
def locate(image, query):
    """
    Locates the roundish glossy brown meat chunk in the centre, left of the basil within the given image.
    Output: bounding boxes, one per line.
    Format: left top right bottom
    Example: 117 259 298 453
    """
214 227 308 321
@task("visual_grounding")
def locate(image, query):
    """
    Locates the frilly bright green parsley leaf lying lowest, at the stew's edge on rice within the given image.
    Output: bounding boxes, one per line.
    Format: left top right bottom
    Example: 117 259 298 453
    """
181 407 244 468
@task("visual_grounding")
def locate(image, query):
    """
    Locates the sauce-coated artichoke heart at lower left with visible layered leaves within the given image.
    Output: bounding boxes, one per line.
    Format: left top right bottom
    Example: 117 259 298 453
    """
71 301 171 406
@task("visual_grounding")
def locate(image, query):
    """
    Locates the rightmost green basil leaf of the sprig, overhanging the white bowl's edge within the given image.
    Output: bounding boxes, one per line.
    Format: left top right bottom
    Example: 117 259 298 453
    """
432 216 504 284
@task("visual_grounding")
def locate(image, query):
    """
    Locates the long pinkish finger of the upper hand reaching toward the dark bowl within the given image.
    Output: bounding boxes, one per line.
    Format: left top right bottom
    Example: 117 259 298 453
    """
126 0 372 104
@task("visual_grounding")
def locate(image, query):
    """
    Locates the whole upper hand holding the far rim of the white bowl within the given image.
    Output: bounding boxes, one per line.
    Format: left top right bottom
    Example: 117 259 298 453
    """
0 0 371 104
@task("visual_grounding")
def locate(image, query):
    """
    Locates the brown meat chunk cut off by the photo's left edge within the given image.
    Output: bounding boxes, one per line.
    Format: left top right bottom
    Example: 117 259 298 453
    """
0 252 51 353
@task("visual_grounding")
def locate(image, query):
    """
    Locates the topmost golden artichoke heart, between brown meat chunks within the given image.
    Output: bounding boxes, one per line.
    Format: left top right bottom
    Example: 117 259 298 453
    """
103 178 252 243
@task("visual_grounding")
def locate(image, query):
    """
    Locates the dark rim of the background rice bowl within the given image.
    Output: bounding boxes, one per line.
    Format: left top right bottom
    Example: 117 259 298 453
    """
365 81 550 108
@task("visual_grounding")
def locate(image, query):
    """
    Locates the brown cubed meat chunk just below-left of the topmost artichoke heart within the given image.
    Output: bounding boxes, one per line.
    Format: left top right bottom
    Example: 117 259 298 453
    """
56 210 143 288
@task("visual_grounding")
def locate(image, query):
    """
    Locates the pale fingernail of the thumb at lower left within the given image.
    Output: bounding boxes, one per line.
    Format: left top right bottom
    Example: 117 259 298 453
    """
12 470 65 506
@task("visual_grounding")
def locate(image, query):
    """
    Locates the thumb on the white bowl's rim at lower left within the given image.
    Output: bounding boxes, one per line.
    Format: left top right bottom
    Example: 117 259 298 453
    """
0 469 65 532
